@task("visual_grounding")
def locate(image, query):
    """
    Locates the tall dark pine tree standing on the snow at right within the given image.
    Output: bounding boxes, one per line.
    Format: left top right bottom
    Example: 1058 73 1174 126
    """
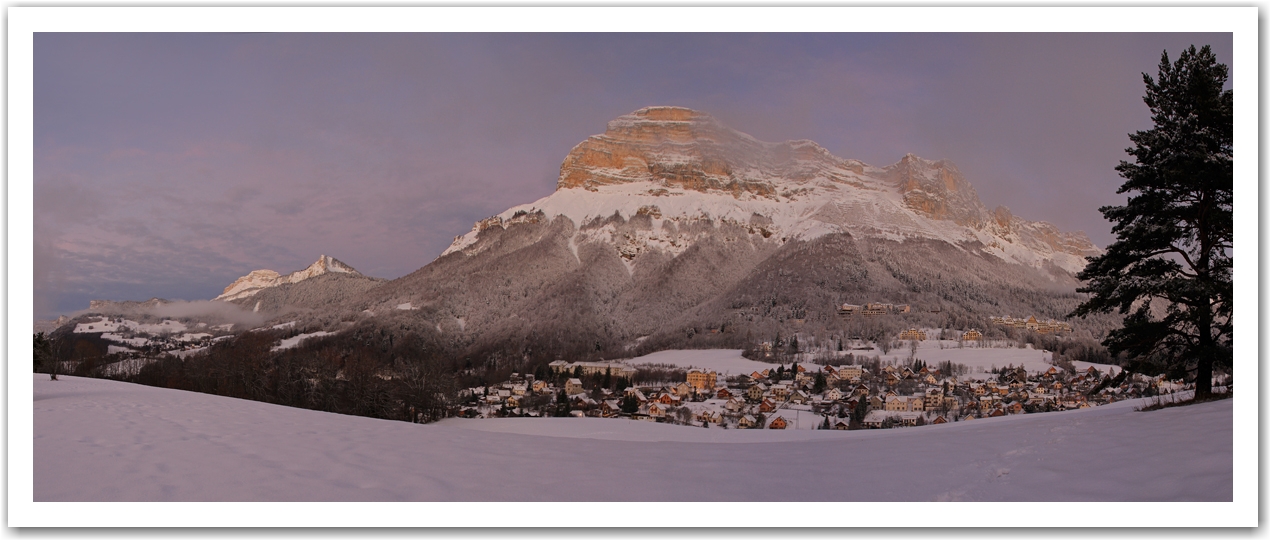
1073 46 1233 399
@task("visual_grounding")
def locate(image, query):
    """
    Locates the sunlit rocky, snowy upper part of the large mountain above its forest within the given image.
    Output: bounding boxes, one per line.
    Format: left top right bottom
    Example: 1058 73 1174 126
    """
445 107 1100 274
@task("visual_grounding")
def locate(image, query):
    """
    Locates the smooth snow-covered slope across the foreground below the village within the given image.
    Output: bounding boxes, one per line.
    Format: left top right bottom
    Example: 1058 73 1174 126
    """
33 375 1233 502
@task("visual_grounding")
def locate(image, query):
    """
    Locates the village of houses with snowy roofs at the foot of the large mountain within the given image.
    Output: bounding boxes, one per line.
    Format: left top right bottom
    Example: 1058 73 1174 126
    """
460 335 1186 429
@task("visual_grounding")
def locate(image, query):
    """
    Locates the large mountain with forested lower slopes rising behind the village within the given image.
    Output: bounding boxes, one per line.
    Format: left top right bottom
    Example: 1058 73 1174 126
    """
340 107 1101 361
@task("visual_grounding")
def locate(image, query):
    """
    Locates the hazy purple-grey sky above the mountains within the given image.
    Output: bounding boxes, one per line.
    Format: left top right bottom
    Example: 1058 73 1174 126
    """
34 33 1236 318
